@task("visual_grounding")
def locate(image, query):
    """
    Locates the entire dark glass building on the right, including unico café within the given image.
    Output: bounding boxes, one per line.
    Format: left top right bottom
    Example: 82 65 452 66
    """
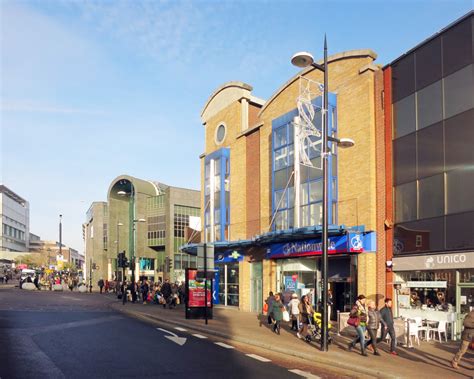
383 12 474 334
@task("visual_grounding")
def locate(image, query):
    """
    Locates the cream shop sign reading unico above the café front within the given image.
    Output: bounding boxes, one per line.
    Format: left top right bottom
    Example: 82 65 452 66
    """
393 252 474 271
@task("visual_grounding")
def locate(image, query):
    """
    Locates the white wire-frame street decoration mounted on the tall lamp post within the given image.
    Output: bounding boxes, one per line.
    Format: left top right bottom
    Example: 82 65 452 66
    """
294 76 324 169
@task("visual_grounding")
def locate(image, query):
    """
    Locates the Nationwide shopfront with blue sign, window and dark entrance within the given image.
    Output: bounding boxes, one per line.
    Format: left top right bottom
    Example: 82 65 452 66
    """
267 234 364 319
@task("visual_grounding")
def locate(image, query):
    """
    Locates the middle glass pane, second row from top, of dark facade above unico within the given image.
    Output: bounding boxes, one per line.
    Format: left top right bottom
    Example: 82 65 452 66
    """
417 80 443 129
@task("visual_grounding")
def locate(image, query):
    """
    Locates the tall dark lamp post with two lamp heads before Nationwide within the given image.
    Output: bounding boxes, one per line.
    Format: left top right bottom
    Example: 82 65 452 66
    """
291 36 354 351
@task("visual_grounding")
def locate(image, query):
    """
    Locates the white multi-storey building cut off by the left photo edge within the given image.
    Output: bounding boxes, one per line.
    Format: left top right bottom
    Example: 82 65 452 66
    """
0 185 30 252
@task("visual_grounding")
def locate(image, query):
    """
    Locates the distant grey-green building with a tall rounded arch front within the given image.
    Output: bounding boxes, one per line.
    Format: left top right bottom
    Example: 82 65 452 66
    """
84 175 201 285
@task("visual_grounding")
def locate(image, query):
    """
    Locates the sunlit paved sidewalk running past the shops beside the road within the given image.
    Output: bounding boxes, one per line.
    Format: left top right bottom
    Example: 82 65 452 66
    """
109 295 474 378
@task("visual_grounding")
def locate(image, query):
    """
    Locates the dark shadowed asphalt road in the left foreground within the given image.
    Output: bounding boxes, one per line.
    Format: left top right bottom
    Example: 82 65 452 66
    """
0 287 312 379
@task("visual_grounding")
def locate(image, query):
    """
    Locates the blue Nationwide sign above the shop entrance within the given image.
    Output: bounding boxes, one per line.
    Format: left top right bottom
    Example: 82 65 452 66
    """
267 233 364 258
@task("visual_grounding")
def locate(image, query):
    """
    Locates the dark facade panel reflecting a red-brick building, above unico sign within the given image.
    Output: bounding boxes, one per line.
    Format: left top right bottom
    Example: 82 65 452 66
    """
393 217 444 255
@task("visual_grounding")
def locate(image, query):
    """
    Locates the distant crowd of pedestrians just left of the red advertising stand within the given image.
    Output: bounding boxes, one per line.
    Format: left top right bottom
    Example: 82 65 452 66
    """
108 279 185 309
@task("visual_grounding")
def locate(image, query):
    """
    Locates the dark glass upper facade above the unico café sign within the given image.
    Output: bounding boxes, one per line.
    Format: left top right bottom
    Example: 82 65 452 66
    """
392 16 474 254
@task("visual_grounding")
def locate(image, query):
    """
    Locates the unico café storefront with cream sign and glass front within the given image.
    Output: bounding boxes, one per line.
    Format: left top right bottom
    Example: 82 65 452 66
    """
393 252 474 336
